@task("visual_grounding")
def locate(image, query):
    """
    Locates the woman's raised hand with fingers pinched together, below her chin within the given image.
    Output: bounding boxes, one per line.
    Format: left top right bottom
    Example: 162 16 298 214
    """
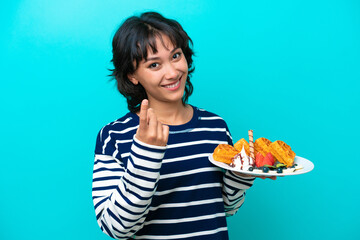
136 99 169 146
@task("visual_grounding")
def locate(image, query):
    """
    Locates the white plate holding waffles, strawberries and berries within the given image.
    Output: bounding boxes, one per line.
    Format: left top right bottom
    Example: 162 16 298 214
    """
209 154 314 176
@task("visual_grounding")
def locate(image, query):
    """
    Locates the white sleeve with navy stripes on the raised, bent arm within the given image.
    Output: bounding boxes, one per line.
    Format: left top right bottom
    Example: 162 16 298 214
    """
92 137 166 239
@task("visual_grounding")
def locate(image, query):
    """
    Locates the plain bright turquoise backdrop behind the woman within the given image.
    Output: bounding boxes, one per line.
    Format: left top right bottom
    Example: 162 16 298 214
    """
0 0 360 240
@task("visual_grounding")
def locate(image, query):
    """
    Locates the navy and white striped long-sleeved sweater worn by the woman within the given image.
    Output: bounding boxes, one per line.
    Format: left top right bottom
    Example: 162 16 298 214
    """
92 107 254 240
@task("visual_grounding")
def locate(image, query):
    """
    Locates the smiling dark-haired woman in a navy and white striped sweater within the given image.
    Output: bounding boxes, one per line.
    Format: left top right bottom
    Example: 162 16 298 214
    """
93 12 255 240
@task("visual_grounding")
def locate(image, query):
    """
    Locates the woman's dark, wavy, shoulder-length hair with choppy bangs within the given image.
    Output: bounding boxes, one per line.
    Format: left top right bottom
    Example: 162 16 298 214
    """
110 12 195 113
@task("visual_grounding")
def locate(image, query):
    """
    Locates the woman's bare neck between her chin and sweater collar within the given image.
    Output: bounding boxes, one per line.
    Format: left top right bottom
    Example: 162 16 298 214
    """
149 101 193 125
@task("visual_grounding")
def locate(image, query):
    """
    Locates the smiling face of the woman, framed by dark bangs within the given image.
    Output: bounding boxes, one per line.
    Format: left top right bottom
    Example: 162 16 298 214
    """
129 35 188 105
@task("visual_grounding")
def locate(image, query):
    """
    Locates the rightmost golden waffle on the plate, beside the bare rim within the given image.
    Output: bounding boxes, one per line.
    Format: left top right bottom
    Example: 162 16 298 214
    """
269 140 295 167
